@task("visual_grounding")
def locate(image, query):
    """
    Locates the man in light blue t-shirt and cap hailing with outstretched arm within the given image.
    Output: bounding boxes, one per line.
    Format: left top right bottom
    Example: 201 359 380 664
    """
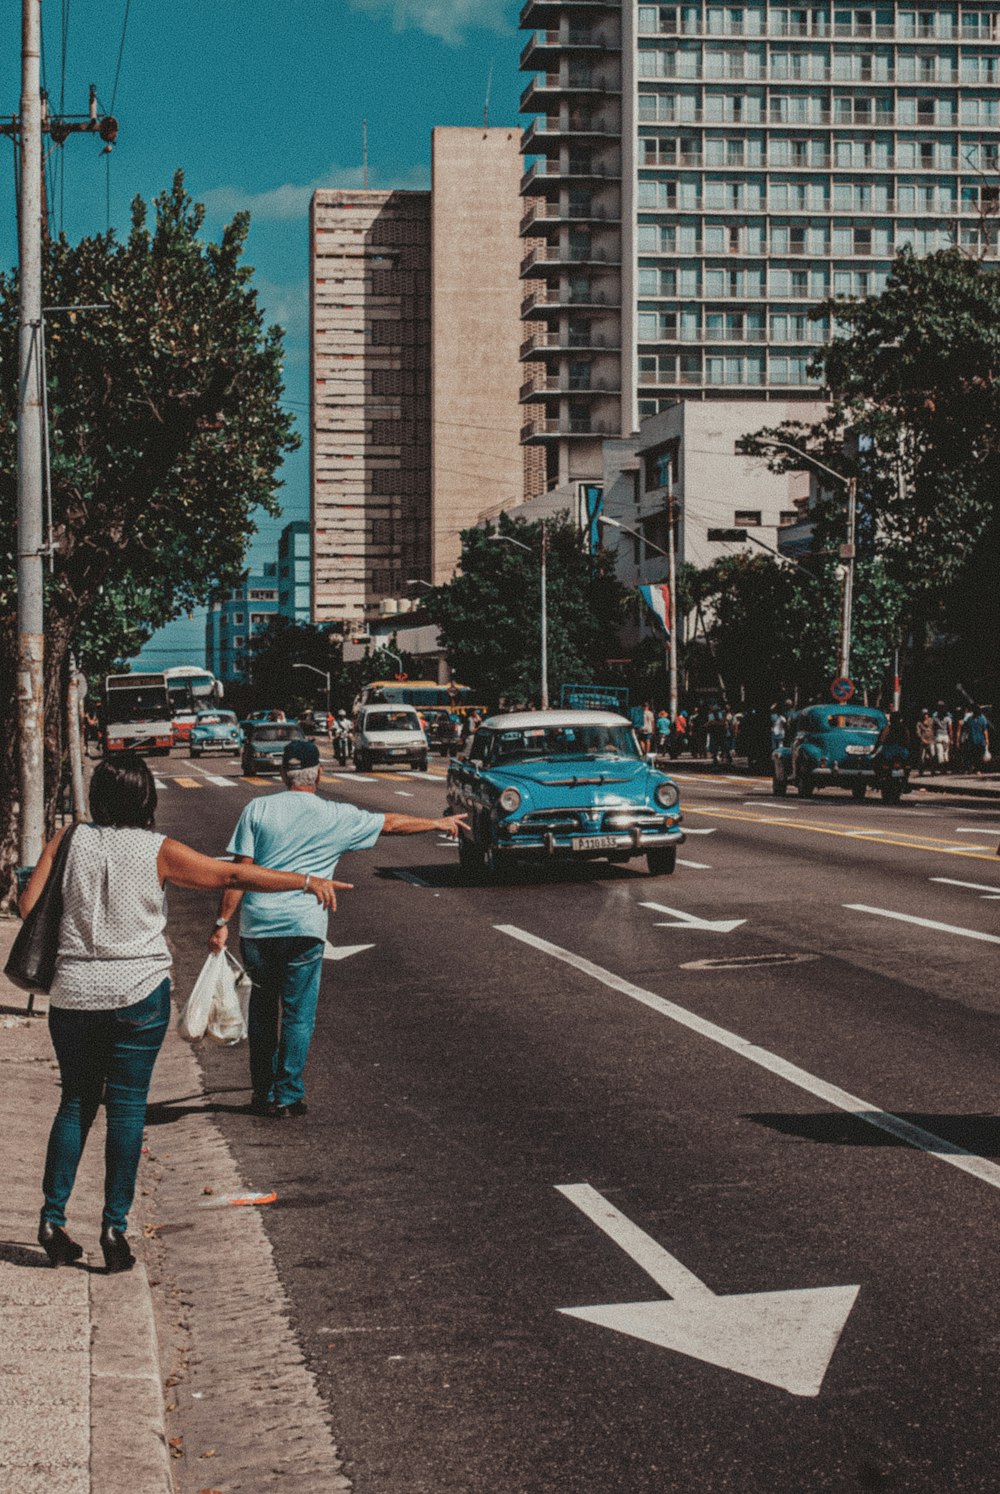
209 741 465 1119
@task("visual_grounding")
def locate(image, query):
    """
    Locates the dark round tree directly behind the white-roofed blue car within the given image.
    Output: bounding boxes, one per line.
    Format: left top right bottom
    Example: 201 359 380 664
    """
425 514 623 705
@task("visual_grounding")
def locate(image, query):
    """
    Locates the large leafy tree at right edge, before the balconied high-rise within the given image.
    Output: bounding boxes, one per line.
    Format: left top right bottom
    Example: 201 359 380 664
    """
746 249 1000 699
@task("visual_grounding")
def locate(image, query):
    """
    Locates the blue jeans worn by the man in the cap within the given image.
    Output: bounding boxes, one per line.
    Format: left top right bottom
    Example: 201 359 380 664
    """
241 938 323 1106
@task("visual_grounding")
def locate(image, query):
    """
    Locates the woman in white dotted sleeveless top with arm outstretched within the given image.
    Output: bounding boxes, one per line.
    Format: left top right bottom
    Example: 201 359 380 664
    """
19 751 347 1273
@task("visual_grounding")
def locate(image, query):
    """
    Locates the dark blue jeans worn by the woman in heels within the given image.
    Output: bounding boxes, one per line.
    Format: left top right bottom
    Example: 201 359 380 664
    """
42 980 170 1230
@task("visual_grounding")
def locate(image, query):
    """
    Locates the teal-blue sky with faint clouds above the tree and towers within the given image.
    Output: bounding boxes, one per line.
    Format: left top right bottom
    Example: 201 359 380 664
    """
0 0 525 666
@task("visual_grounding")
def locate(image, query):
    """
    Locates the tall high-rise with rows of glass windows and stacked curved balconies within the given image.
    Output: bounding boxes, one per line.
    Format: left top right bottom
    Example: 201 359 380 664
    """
522 0 1000 480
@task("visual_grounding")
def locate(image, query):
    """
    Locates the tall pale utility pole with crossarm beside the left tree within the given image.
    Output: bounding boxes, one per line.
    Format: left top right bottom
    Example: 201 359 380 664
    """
0 0 118 867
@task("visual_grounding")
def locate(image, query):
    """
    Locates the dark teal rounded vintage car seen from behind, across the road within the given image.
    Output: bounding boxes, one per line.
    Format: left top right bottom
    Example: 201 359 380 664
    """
771 704 886 799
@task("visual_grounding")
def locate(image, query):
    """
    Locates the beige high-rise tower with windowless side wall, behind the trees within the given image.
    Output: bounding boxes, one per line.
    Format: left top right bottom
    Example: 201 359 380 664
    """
311 128 529 626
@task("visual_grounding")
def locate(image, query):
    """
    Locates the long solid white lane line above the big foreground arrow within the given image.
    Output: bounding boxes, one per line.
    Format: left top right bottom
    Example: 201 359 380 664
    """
493 923 1000 1188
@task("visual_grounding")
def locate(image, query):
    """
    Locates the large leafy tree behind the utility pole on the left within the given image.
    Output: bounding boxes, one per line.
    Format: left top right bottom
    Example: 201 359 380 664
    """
0 173 297 889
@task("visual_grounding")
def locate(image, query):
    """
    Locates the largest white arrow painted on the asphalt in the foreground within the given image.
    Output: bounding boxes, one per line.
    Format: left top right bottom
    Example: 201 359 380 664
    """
556 1183 861 1395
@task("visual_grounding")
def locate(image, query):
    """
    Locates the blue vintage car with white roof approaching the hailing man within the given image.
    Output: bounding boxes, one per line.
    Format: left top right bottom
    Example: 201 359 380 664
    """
447 711 685 880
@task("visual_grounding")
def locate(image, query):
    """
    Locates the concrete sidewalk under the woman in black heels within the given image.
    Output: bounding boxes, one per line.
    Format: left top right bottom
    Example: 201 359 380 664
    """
0 919 172 1494
